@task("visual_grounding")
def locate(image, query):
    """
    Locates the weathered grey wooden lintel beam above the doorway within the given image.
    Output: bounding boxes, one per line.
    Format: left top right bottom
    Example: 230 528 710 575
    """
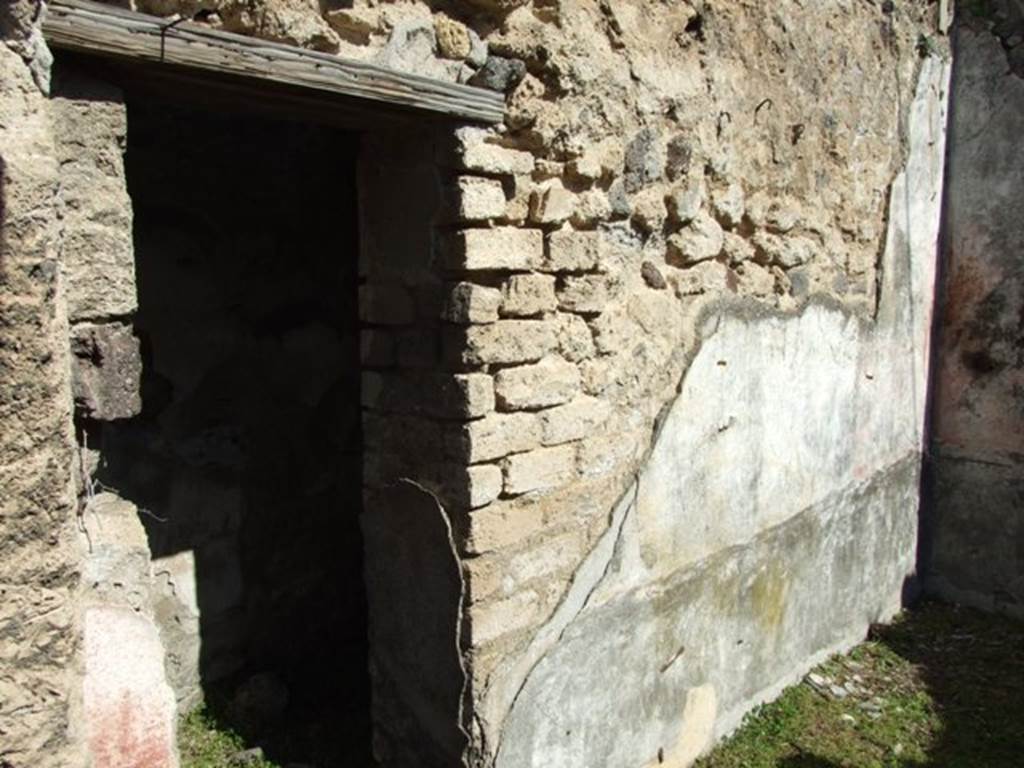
43 0 505 123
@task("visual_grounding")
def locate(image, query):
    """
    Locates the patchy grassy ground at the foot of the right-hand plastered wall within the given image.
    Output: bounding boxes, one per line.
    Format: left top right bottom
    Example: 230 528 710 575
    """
697 604 1024 768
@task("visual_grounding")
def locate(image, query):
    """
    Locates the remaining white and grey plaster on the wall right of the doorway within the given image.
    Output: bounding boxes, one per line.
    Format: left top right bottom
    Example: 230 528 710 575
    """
478 57 949 768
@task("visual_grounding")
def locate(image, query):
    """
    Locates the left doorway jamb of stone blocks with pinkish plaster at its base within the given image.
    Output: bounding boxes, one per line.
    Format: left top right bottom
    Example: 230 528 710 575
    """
49 54 178 768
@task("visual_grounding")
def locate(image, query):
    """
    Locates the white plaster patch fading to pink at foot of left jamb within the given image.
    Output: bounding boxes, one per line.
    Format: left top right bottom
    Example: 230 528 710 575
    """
83 607 178 768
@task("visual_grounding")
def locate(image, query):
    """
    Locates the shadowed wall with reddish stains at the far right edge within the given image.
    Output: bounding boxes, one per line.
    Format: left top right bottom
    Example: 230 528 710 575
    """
928 0 1024 615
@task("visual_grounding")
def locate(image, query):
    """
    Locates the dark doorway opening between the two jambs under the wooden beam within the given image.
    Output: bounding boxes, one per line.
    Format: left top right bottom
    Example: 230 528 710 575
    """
95 82 371 766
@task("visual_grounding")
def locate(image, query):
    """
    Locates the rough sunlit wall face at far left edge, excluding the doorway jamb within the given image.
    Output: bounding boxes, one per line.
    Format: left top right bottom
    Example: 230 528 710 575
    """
0 2 81 767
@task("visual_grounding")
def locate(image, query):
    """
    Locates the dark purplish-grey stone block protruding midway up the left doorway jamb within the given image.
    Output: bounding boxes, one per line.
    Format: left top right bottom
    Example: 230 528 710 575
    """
71 323 142 421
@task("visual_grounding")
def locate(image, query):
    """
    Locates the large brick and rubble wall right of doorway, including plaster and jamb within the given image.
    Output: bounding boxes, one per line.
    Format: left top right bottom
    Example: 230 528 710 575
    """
4 0 947 767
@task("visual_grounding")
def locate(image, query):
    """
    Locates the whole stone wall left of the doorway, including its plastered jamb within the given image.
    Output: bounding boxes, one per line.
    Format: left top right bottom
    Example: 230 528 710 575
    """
0 7 176 767
